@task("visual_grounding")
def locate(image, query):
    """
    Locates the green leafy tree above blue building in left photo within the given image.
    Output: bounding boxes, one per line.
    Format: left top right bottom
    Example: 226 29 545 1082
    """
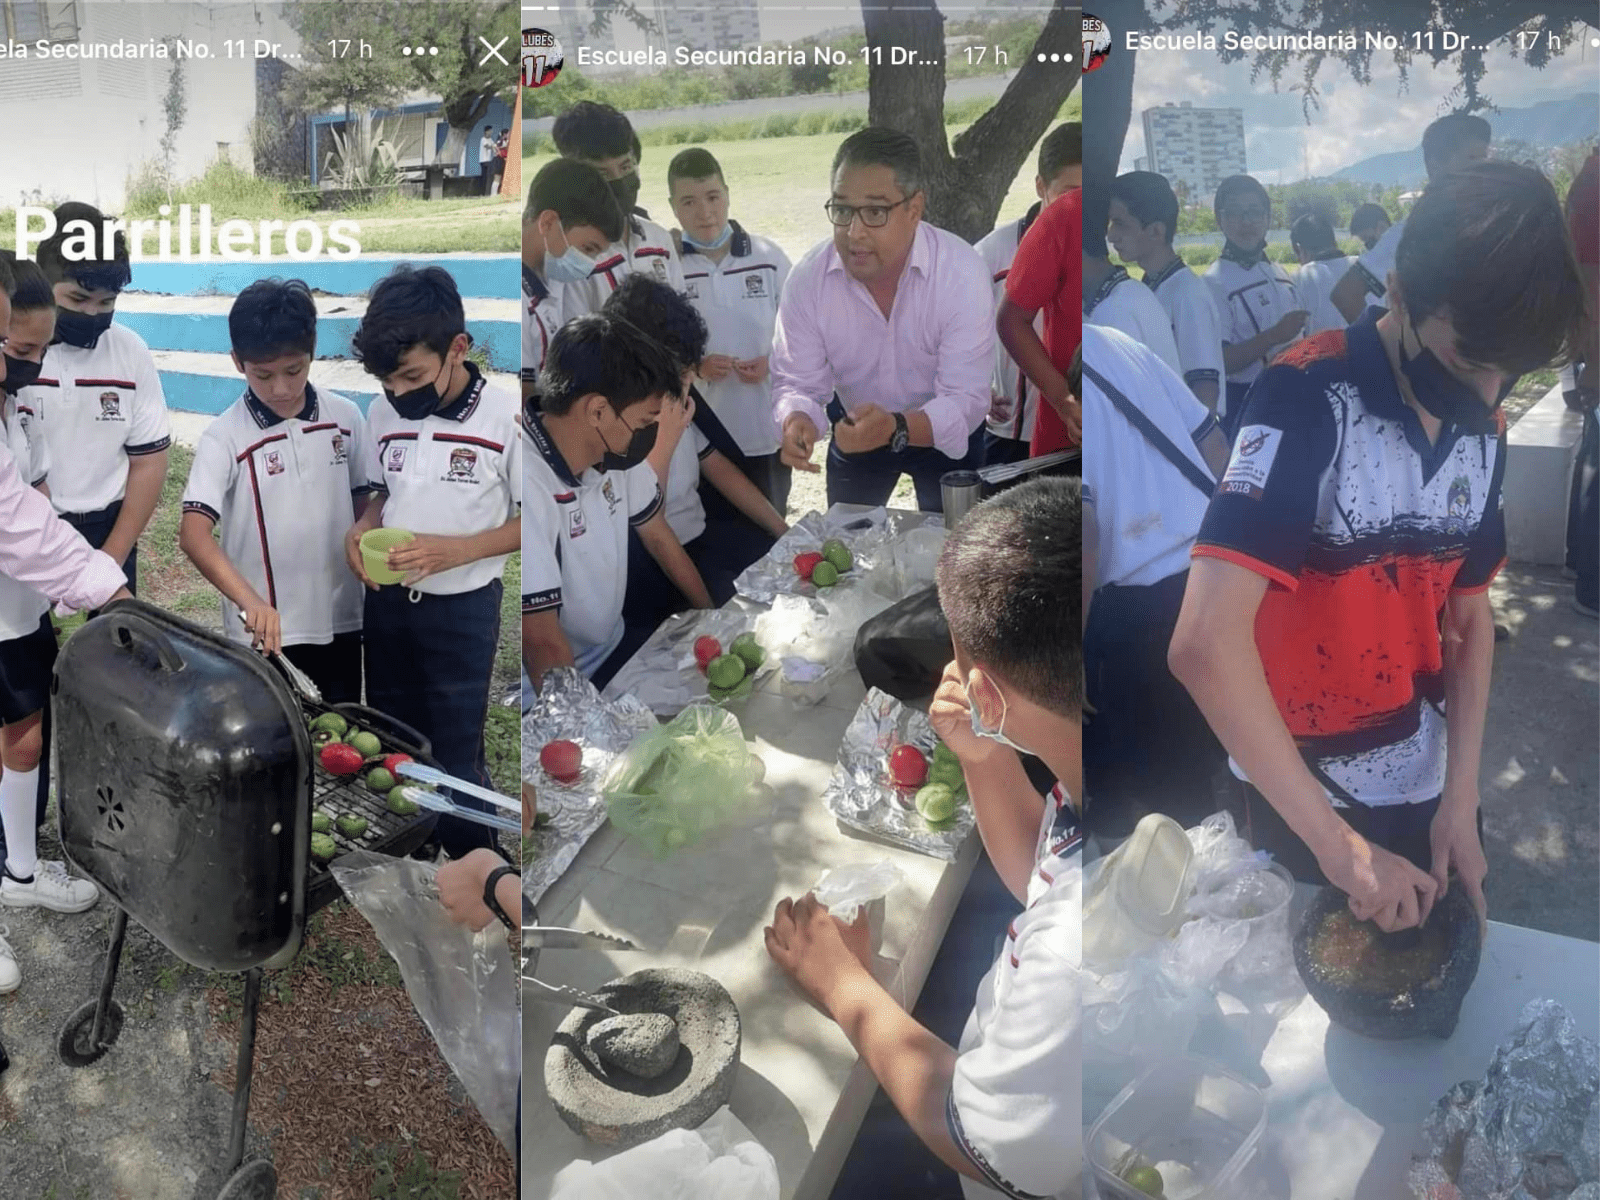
288 0 518 170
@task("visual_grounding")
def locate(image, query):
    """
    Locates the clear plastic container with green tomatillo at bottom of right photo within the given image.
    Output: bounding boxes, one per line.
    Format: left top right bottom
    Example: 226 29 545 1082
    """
1085 1056 1267 1200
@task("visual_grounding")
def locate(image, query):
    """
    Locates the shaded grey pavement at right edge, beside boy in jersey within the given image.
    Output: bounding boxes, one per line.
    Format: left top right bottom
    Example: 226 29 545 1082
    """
1478 563 1600 941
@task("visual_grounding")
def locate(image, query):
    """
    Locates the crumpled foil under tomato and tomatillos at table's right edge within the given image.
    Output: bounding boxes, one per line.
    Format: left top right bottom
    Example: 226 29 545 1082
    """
822 688 976 862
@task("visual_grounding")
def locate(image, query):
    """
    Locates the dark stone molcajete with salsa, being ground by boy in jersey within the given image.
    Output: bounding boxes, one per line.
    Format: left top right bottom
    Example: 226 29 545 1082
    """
1294 882 1482 1040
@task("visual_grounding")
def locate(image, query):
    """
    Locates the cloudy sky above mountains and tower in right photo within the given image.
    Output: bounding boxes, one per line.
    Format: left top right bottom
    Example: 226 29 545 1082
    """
1120 27 1600 182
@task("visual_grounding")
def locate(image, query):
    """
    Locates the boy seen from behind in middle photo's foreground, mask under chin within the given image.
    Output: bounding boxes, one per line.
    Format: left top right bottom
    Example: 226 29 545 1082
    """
766 478 1083 1200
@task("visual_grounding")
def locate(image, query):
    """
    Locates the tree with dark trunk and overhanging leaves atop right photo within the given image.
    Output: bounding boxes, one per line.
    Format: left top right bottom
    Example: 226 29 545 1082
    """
1083 0 1595 206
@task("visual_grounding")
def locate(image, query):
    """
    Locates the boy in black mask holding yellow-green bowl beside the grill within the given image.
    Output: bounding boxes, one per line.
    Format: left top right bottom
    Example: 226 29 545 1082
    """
344 262 522 858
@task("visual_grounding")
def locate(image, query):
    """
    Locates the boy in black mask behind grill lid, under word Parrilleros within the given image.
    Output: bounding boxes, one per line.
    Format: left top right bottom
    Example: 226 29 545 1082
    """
24 203 173 592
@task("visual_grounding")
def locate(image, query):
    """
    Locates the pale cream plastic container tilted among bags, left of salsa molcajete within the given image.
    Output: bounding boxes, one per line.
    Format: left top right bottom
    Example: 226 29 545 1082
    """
1083 813 1195 971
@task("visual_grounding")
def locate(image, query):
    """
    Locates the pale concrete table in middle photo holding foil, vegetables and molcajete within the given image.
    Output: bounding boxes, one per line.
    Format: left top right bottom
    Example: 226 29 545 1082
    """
522 508 979 1200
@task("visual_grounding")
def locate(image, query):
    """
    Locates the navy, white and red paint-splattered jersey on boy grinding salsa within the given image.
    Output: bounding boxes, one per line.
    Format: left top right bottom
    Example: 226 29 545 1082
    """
1194 309 1506 805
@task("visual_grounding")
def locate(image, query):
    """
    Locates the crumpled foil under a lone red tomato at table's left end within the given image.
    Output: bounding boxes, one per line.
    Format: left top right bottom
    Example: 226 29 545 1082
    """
522 667 656 902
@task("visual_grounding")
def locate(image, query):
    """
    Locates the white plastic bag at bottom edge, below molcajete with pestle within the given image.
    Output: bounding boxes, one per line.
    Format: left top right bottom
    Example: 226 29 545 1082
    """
550 1106 778 1200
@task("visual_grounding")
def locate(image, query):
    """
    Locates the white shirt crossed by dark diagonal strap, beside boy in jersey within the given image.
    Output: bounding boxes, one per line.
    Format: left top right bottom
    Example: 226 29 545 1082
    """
1083 325 1216 587
